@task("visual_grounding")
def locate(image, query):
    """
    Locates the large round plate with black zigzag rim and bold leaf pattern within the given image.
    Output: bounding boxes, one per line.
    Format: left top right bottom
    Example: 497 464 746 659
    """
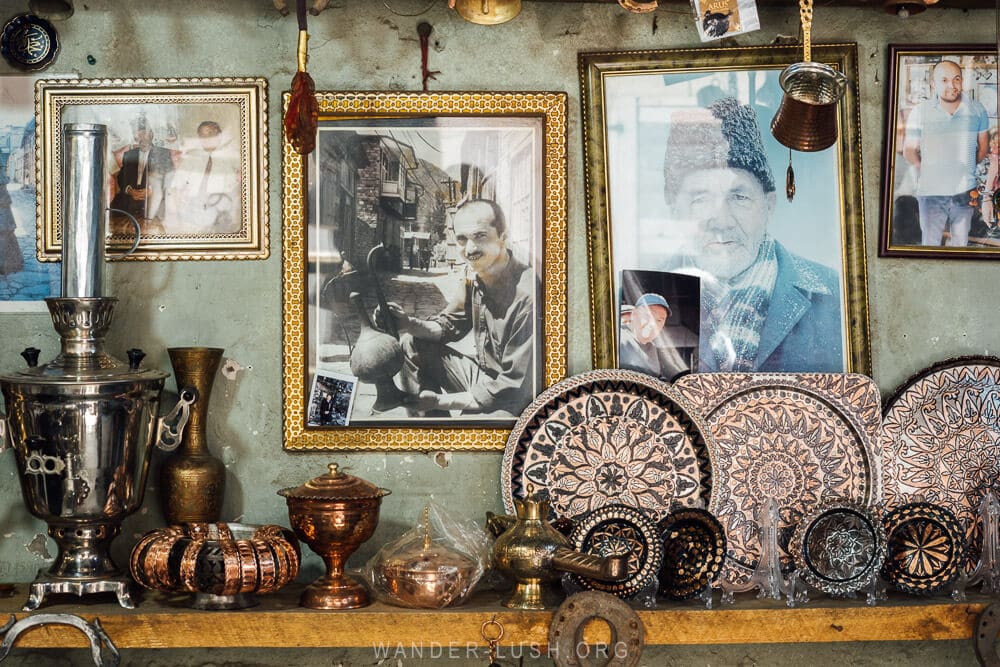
501 370 712 521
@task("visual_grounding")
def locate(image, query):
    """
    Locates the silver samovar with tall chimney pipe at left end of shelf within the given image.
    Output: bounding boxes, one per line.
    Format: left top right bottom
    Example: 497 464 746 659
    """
0 124 197 611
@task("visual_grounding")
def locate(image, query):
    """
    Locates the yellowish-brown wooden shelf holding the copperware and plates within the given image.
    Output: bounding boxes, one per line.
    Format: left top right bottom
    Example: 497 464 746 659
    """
0 585 992 649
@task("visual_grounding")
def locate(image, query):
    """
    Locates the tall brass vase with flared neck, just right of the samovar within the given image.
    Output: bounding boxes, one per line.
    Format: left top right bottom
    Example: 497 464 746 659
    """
160 347 226 525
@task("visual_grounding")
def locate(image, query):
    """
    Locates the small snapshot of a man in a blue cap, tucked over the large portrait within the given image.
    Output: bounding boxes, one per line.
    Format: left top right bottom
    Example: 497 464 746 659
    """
618 270 701 381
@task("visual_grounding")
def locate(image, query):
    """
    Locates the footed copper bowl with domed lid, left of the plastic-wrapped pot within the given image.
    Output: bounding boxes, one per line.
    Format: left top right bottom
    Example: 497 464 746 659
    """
278 463 391 609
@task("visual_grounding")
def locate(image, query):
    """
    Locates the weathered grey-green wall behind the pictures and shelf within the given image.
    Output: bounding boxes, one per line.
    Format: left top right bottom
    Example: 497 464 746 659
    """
0 0 1000 665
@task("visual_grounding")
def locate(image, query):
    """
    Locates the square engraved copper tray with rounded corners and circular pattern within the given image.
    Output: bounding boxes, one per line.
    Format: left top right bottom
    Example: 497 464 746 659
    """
674 373 881 583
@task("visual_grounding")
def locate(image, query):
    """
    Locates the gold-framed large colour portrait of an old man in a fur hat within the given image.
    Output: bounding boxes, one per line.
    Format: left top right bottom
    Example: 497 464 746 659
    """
579 44 871 373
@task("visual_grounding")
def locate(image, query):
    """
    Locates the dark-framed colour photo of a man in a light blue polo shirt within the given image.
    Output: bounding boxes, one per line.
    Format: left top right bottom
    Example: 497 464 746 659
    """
879 45 1000 259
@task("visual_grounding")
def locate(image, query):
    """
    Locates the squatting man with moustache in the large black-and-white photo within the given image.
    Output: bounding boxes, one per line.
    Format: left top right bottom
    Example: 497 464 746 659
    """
380 199 541 417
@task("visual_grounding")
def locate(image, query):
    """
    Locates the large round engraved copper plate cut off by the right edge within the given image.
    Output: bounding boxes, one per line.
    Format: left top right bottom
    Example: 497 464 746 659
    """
882 357 1000 571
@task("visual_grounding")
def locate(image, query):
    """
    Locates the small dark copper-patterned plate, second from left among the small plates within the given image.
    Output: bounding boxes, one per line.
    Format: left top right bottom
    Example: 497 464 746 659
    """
657 509 726 600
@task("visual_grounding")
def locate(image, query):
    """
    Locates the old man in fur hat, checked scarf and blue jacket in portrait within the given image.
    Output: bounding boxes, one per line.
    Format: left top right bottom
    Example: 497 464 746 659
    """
663 97 844 372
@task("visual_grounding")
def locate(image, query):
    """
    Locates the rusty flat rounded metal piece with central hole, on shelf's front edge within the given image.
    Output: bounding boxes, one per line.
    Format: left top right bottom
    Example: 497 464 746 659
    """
549 591 646 667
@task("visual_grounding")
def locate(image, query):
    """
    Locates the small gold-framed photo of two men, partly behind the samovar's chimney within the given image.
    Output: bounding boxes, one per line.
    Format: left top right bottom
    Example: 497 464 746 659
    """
35 78 270 262
